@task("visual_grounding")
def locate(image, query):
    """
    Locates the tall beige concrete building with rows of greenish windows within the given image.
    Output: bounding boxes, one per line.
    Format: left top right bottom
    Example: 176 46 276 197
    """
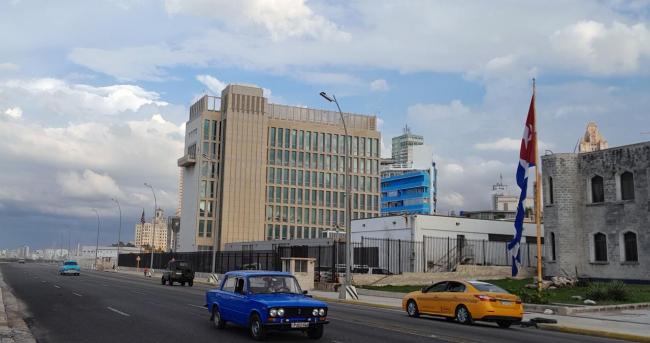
178 84 380 251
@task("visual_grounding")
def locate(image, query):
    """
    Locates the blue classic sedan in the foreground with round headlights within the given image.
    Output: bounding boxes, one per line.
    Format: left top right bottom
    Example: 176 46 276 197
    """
205 270 328 340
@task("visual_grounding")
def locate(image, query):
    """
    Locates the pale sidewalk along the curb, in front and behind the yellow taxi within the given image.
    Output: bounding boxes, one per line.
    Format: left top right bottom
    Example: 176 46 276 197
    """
309 291 650 342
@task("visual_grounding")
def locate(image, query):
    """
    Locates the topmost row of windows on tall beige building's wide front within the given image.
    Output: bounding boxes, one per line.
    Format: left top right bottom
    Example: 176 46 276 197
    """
268 127 379 157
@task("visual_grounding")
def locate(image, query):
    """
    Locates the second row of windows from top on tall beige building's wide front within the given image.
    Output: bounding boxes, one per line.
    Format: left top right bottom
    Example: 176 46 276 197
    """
268 149 379 174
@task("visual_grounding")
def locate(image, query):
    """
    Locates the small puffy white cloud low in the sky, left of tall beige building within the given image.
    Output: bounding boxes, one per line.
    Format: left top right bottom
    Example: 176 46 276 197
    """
56 169 122 199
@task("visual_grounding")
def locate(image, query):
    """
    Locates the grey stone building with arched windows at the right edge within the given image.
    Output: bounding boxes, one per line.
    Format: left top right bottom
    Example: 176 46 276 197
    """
542 142 650 280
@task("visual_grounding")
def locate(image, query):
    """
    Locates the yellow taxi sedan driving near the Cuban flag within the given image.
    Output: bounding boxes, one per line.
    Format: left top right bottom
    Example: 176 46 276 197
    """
402 281 524 328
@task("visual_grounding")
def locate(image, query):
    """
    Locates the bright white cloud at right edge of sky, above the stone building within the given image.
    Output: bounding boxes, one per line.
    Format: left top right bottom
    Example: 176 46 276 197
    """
550 20 650 74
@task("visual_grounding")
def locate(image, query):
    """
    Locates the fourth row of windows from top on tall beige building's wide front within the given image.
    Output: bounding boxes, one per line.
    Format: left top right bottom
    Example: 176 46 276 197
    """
266 186 379 211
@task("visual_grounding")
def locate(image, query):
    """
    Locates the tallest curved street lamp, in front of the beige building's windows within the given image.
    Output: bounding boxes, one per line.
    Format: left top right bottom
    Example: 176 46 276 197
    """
320 92 358 300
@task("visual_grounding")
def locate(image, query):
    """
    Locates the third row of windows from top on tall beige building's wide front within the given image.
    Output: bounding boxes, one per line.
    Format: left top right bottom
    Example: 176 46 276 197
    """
266 167 379 193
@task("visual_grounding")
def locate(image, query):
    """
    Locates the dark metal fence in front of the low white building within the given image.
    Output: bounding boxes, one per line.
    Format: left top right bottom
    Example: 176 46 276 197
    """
277 236 537 279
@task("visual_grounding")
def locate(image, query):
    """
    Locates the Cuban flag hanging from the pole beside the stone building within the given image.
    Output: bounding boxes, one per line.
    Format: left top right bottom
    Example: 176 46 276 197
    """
508 94 537 276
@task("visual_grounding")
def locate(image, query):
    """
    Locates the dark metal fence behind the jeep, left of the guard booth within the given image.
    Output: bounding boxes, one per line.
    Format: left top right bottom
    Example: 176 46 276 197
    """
118 250 281 274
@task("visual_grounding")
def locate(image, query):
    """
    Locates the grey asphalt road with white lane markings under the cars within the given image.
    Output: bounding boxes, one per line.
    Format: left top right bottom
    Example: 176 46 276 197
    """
0 263 614 343
